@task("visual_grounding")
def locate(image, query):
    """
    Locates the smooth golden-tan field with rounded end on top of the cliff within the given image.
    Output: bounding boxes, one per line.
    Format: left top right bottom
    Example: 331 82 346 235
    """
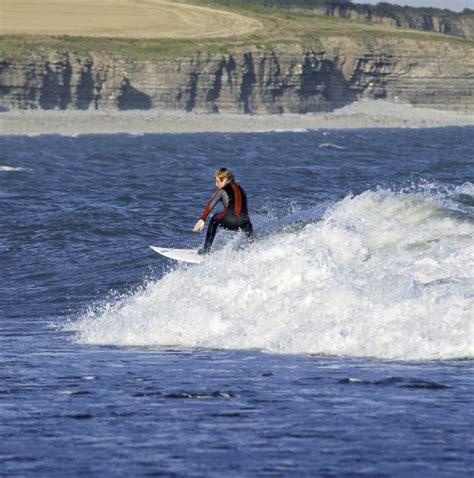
0 0 261 39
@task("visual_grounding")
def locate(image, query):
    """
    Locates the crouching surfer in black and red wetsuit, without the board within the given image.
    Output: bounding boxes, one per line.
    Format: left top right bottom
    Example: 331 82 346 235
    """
193 168 255 254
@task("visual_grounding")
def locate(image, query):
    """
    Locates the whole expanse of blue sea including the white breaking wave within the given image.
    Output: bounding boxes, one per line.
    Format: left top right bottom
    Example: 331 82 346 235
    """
0 128 474 477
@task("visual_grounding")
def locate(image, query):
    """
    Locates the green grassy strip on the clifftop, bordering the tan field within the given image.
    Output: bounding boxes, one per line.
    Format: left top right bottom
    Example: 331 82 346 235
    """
0 0 474 59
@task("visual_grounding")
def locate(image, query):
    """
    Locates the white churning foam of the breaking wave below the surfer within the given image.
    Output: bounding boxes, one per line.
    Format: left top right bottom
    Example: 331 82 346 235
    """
71 184 474 360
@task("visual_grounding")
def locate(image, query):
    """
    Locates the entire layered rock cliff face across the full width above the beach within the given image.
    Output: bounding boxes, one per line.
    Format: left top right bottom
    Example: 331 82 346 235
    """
0 37 474 113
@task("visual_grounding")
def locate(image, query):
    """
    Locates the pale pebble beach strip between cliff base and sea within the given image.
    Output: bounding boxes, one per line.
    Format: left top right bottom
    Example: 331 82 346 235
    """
0 100 474 135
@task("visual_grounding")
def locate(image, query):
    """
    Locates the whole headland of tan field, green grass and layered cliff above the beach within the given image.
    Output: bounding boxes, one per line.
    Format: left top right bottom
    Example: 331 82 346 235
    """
0 0 474 114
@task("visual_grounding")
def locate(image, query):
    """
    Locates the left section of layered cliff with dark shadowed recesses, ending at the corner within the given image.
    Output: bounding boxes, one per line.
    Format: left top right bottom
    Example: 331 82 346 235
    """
0 51 354 113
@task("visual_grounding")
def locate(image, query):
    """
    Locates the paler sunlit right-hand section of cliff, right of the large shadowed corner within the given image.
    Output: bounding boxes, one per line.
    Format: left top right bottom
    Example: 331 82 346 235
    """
326 38 474 113
